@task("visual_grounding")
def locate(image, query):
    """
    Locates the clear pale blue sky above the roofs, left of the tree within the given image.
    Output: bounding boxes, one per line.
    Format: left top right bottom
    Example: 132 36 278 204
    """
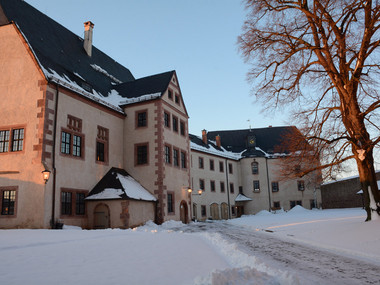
26 0 288 136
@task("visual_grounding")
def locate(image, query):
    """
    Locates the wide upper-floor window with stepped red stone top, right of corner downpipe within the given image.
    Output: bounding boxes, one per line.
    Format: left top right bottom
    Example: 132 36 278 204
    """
61 115 84 157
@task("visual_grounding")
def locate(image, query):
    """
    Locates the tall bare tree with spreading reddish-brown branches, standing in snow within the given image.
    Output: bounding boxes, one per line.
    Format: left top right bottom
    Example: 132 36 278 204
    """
239 0 380 220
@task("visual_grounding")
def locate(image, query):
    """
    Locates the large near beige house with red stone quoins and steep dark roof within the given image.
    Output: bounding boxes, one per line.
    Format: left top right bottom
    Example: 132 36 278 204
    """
0 0 190 228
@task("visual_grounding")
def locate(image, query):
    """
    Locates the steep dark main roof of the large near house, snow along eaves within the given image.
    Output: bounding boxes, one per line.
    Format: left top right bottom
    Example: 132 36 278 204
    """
0 0 174 112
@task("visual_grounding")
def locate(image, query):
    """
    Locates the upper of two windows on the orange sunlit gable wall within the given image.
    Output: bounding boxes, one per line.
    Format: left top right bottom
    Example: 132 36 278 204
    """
0 125 26 155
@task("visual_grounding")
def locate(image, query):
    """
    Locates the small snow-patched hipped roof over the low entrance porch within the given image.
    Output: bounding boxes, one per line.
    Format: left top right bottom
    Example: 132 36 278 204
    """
86 167 157 201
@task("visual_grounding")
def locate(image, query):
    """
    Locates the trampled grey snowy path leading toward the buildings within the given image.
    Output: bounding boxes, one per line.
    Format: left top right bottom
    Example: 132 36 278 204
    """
180 221 380 284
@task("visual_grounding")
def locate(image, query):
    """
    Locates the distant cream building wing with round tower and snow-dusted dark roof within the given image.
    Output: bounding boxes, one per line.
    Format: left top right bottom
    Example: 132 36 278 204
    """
190 127 321 220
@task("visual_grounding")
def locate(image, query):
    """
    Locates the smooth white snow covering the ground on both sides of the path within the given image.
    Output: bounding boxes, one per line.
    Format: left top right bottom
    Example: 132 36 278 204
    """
0 206 380 285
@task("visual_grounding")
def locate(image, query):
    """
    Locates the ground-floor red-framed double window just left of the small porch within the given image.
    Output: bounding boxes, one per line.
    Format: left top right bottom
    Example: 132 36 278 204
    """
60 188 88 218
